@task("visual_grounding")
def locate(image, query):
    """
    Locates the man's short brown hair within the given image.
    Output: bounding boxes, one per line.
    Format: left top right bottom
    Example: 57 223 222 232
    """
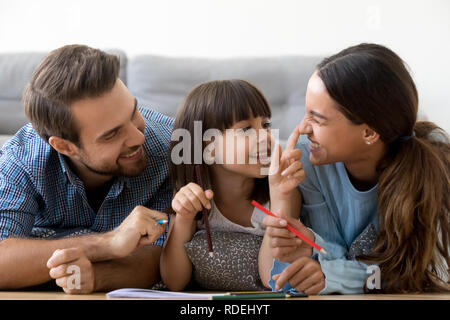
22 45 120 145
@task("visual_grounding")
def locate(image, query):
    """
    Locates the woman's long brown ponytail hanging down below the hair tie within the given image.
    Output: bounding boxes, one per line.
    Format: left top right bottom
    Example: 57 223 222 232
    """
368 121 450 292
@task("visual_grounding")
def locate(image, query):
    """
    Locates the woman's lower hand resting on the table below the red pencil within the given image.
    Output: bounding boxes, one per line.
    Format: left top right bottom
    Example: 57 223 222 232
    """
272 257 325 295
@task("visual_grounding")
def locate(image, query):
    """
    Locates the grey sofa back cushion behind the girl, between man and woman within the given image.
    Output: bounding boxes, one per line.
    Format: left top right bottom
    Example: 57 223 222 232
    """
127 55 321 139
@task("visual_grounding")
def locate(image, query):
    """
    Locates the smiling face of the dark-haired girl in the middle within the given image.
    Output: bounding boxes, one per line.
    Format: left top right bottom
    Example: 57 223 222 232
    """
215 117 272 178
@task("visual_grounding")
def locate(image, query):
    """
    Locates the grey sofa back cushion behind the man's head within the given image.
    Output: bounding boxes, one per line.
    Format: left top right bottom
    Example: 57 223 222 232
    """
0 49 127 135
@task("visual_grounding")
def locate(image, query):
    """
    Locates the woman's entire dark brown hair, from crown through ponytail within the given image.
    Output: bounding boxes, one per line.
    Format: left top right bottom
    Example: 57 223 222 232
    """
318 44 450 292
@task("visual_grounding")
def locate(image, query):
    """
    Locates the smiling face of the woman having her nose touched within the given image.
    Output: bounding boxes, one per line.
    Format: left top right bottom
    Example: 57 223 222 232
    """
299 72 368 165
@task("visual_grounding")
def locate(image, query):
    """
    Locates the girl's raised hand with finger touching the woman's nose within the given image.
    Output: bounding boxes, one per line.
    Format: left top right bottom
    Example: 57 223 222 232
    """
269 127 305 198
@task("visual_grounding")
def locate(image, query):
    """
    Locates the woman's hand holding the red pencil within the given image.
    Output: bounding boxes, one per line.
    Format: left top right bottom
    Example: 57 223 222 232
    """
263 213 315 262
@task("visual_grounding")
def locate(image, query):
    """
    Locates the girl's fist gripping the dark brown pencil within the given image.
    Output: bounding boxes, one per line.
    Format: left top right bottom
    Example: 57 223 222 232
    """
172 182 214 220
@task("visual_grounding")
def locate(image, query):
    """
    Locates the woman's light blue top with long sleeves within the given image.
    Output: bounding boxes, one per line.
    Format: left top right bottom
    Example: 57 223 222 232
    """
269 135 377 294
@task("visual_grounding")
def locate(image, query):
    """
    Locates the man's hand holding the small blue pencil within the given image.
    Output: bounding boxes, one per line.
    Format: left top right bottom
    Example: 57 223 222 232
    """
109 206 167 258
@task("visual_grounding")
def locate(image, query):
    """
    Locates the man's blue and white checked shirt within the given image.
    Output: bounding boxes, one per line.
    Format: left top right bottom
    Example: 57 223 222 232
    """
0 108 173 245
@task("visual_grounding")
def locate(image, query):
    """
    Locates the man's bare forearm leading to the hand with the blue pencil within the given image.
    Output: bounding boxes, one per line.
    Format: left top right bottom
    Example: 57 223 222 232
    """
0 234 113 289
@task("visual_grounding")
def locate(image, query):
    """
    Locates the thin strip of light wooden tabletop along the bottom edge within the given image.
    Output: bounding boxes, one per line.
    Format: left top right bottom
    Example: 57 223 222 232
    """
0 291 450 300
